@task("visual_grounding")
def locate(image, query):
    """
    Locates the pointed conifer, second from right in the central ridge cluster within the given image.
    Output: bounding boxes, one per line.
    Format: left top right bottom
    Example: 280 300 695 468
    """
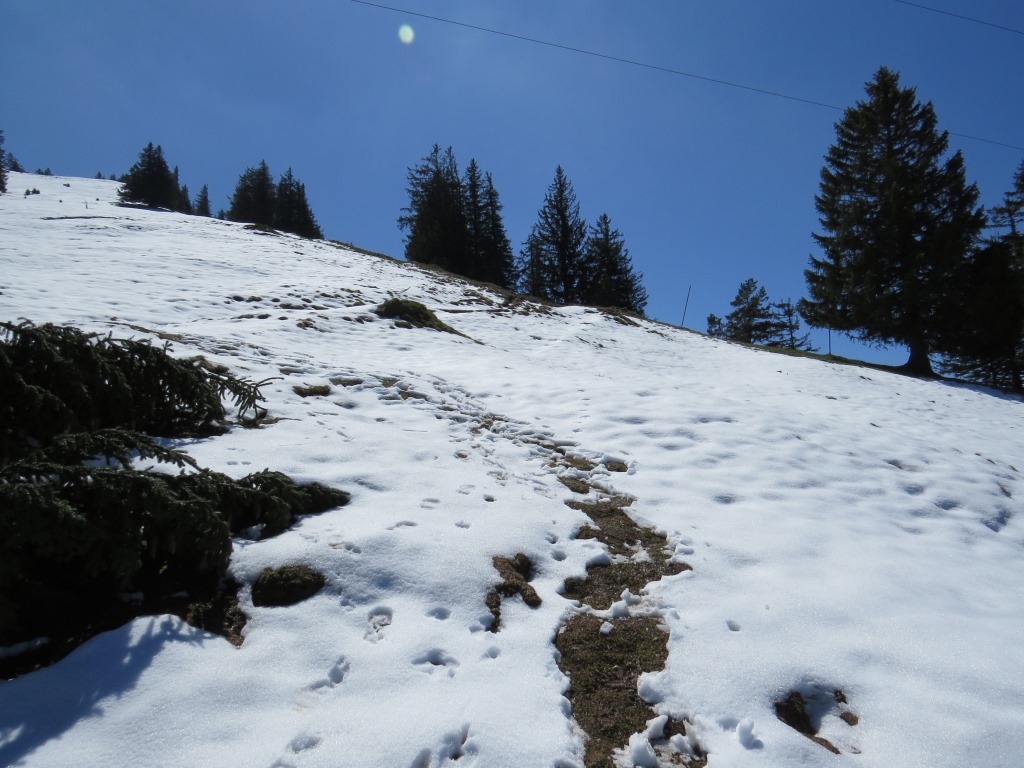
520 166 587 304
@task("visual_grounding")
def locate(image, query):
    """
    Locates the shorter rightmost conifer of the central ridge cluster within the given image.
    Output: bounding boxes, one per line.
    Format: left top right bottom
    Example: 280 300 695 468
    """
583 213 647 314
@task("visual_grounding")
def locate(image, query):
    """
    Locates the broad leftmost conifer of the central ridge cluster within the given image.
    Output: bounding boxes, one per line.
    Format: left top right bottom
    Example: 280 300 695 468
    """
398 144 468 274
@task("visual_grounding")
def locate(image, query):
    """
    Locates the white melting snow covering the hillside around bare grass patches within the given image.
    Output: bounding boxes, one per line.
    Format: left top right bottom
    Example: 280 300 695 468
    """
0 173 1024 768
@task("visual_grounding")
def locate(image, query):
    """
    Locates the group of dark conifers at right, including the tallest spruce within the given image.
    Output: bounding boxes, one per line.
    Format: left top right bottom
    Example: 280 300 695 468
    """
708 68 1024 390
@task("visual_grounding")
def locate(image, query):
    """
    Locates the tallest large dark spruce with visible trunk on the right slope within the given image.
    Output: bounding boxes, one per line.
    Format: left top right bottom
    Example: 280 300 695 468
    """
800 68 984 374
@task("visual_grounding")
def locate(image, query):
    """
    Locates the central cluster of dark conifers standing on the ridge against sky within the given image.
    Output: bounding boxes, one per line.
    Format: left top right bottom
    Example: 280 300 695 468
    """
398 144 647 314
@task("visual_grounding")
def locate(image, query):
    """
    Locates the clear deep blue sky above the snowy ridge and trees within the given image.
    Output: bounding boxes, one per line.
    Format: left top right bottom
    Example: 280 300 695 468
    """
0 0 1024 362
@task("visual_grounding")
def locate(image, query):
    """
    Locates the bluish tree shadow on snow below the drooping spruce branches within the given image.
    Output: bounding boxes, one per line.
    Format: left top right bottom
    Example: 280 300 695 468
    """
0 615 211 766
